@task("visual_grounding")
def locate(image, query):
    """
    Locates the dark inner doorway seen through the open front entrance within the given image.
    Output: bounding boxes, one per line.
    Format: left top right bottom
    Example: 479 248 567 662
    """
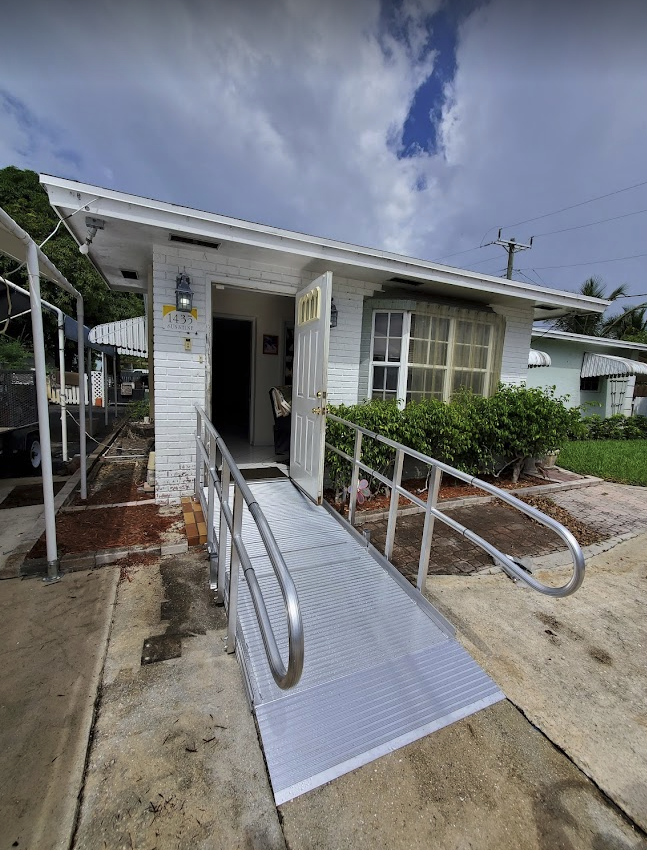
211 318 253 440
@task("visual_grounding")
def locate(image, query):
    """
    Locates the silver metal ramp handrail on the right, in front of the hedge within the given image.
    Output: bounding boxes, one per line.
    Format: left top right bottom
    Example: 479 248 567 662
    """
326 413 585 597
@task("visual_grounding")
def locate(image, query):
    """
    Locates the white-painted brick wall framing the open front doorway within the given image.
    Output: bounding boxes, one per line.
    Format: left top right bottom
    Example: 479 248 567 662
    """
153 244 379 496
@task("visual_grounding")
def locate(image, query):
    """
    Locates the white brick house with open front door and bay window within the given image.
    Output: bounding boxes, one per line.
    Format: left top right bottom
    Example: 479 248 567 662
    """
41 175 607 501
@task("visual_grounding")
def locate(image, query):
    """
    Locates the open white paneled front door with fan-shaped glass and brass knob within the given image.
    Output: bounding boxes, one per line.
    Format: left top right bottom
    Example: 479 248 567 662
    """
290 272 332 505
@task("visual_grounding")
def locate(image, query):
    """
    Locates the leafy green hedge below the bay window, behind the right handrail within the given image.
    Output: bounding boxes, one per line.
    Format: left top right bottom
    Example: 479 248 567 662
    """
326 386 582 489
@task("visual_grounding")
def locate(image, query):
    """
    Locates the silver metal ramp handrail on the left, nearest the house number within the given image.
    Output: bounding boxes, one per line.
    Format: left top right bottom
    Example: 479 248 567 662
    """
196 405 304 690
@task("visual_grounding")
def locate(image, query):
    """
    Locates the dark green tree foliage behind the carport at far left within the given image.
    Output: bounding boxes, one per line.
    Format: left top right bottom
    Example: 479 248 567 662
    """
0 166 144 358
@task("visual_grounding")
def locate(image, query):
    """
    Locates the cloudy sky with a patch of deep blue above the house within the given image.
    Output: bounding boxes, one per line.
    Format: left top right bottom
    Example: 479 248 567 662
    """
0 0 647 314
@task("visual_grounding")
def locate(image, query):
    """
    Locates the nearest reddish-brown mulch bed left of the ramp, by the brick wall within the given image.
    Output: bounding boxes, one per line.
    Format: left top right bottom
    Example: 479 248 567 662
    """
27 505 184 558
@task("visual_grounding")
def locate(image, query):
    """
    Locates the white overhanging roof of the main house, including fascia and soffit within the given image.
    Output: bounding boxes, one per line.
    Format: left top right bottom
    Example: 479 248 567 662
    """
40 174 609 319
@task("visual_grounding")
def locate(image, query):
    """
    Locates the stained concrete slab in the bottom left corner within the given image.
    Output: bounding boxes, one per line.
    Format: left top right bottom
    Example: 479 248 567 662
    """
0 568 119 850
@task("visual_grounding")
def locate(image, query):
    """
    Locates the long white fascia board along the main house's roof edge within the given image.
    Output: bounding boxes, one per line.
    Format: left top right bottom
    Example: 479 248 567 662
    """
40 174 609 313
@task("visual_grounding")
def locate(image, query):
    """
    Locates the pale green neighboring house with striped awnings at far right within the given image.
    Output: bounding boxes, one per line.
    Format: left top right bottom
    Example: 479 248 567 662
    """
526 328 647 416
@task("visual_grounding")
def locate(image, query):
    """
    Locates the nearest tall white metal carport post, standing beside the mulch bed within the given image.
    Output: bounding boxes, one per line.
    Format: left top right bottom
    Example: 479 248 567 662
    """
27 239 61 582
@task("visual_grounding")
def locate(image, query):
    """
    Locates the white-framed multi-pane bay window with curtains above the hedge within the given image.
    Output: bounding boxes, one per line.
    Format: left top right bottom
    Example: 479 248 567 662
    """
371 305 503 401
